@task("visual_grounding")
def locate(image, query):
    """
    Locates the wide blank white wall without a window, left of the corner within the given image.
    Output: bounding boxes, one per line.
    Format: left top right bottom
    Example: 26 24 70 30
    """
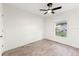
3 4 44 50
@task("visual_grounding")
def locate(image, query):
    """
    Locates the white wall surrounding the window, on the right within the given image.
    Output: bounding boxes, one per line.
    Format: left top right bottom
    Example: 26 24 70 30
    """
45 8 79 48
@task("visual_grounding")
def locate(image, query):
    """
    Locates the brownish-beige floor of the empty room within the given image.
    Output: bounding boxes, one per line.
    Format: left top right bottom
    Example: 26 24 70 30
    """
3 39 79 56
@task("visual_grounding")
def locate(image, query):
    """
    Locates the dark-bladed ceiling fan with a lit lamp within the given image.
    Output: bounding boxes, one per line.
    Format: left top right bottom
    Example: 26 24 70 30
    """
40 3 62 15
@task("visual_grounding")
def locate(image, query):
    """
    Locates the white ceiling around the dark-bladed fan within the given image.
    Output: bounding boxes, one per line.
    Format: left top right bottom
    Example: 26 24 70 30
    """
7 3 79 17
